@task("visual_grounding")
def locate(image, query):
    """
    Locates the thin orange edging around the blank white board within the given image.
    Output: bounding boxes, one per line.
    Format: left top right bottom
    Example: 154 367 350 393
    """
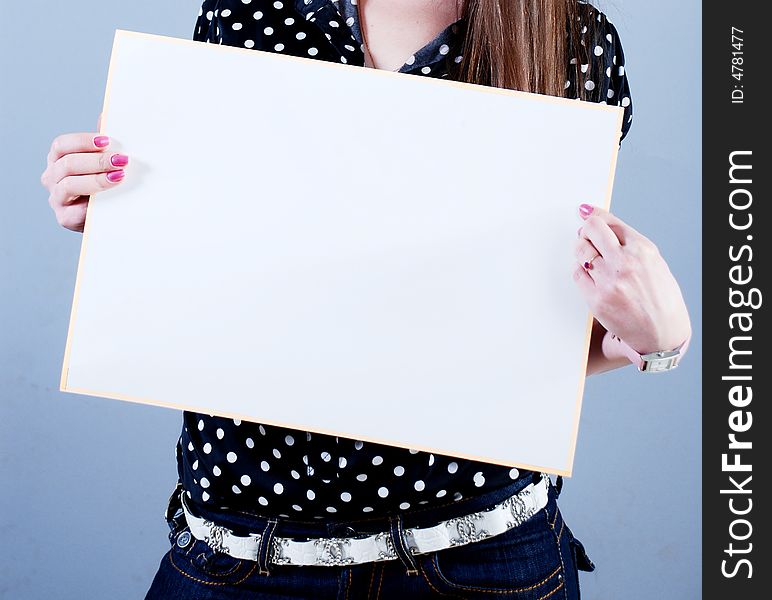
59 29 624 477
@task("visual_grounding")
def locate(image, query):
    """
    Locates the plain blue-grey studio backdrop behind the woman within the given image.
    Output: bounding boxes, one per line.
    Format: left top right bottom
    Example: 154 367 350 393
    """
0 0 701 600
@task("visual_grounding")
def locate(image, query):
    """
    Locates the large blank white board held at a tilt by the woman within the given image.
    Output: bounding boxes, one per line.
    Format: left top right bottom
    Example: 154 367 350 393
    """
61 31 623 475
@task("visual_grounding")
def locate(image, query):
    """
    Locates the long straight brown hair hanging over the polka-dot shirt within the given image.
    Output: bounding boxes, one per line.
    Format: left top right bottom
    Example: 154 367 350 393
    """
455 0 595 98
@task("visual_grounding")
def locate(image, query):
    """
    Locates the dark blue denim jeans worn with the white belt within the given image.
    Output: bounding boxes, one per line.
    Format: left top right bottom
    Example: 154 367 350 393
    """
145 474 595 600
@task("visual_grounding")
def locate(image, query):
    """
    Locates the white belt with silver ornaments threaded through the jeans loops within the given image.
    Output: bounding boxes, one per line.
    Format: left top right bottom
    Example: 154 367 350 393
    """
181 474 549 566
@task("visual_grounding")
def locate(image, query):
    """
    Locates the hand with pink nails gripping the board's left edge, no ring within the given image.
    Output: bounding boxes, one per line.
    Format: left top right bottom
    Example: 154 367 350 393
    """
40 133 129 232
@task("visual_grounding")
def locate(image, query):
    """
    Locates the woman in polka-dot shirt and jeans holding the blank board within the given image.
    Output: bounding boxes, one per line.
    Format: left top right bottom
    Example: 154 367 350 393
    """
42 0 691 599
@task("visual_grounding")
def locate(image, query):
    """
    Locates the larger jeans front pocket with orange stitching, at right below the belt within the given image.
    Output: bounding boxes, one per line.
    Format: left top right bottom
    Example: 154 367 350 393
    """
421 511 564 600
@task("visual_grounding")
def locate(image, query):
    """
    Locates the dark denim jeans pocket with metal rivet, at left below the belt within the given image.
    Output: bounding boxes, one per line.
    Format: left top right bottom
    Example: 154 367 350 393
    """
169 528 257 585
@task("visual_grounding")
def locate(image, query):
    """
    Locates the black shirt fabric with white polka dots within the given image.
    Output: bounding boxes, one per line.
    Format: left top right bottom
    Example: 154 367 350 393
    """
177 0 632 520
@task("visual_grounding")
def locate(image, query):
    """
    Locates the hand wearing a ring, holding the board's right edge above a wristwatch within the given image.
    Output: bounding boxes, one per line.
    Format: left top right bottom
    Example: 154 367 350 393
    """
574 204 691 354
